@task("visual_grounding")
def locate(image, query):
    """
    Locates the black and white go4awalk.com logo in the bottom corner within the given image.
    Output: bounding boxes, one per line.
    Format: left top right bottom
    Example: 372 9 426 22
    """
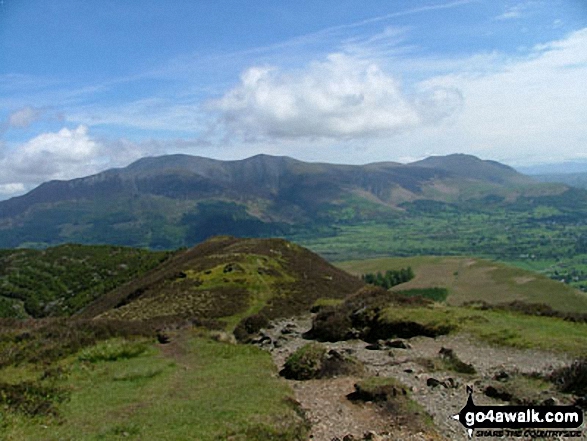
453 386 583 438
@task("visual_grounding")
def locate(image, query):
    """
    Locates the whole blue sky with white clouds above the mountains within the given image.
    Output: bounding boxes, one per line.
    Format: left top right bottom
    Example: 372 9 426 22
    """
0 0 587 199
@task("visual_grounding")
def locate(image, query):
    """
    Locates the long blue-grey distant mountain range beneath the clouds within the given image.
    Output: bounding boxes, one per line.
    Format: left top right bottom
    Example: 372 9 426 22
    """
0 154 567 249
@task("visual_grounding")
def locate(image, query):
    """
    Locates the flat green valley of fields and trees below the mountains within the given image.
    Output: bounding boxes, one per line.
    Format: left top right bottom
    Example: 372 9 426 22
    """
288 201 587 291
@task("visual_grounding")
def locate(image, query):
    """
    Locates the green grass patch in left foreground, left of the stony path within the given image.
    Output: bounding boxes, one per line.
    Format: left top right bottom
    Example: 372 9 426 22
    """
0 331 306 441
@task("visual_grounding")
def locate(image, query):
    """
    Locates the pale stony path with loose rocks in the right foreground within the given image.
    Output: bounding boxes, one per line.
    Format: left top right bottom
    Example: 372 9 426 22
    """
257 316 570 441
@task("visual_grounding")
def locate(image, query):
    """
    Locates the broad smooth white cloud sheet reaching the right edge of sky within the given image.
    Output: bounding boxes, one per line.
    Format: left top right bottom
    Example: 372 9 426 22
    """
382 29 587 164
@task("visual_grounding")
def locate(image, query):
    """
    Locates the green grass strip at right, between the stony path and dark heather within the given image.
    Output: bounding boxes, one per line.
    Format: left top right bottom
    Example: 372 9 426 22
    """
382 305 587 356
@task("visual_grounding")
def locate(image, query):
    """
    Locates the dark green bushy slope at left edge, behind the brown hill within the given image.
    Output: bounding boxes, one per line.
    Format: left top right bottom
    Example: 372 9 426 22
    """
0 245 171 318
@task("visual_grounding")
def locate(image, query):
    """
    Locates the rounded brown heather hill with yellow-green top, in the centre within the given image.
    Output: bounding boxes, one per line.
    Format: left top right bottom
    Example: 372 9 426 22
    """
80 237 362 329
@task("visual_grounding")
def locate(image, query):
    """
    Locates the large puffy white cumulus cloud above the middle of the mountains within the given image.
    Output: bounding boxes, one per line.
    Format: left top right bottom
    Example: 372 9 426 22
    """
208 54 462 139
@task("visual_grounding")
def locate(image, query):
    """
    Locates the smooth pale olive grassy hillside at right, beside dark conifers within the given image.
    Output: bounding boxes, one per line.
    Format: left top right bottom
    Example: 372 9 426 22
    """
339 257 587 312
